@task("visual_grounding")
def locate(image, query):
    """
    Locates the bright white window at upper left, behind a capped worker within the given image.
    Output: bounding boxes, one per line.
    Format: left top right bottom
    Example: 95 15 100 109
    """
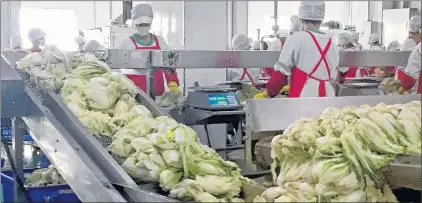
20 8 78 50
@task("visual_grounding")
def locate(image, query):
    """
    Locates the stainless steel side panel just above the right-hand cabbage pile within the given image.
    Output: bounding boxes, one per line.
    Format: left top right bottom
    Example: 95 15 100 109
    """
246 94 421 132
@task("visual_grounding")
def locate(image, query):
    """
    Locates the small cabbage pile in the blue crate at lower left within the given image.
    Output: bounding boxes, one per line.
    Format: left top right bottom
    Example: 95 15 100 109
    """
25 166 66 187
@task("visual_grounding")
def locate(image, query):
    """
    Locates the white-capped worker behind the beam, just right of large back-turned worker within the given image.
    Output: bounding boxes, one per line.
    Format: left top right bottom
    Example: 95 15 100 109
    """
338 32 368 78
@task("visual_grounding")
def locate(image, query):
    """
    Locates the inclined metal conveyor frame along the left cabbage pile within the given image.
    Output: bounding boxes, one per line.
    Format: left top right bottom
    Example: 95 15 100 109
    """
1 54 176 202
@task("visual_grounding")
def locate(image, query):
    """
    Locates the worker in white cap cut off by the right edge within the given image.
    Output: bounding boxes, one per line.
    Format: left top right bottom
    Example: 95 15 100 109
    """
395 16 421 80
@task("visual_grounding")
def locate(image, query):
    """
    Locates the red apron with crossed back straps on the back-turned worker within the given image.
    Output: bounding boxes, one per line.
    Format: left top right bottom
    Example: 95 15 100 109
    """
289 30 331 98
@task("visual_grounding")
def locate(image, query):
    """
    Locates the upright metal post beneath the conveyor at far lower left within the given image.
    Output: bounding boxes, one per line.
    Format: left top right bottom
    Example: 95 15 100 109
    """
12 118 26 202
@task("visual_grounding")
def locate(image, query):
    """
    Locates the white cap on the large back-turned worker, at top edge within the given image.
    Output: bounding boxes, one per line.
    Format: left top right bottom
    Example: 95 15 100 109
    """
299 1 325 21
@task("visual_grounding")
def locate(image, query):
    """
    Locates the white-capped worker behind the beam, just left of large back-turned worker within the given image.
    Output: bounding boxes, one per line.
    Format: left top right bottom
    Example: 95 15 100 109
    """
229 34 260 85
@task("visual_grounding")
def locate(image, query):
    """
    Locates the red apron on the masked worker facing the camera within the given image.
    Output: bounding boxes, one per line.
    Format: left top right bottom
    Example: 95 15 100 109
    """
126 35 177 96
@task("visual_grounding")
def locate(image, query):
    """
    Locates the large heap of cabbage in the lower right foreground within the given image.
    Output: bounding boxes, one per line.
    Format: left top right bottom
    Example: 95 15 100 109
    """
254 101 421 202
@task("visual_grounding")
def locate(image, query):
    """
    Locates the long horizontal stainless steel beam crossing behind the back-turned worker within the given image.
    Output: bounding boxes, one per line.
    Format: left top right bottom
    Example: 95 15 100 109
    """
107 49 410 69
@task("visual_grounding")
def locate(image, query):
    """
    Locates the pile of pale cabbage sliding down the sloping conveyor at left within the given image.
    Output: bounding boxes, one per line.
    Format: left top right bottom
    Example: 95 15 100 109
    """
18 50 250 202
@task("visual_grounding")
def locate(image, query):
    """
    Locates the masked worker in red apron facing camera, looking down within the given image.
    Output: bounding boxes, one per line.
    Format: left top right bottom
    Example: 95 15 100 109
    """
117 4 182 96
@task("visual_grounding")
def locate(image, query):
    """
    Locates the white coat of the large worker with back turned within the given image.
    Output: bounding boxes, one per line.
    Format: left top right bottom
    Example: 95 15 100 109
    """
274 31 340 97
